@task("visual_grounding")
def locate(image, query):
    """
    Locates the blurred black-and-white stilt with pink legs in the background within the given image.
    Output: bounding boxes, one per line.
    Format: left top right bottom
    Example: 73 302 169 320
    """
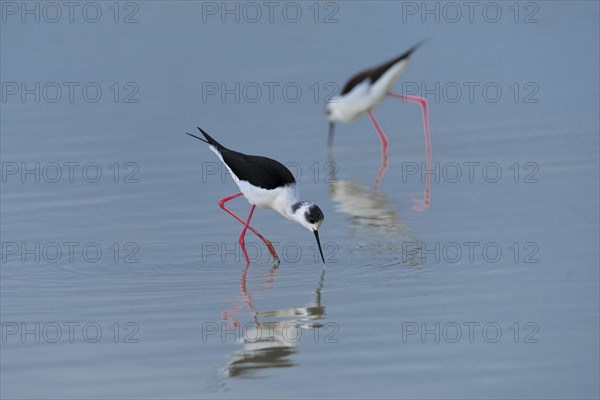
325 42 431 207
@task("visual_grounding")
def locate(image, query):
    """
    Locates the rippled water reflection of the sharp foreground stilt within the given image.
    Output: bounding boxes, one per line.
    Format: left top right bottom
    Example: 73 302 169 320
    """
222 265 325 378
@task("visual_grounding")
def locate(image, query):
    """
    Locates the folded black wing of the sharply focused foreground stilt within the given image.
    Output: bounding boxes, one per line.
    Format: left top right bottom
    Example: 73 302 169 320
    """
198 128 296 189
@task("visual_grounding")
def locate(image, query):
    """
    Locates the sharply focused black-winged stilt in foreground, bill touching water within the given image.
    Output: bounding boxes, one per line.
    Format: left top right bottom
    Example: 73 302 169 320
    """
186 128 325 265
